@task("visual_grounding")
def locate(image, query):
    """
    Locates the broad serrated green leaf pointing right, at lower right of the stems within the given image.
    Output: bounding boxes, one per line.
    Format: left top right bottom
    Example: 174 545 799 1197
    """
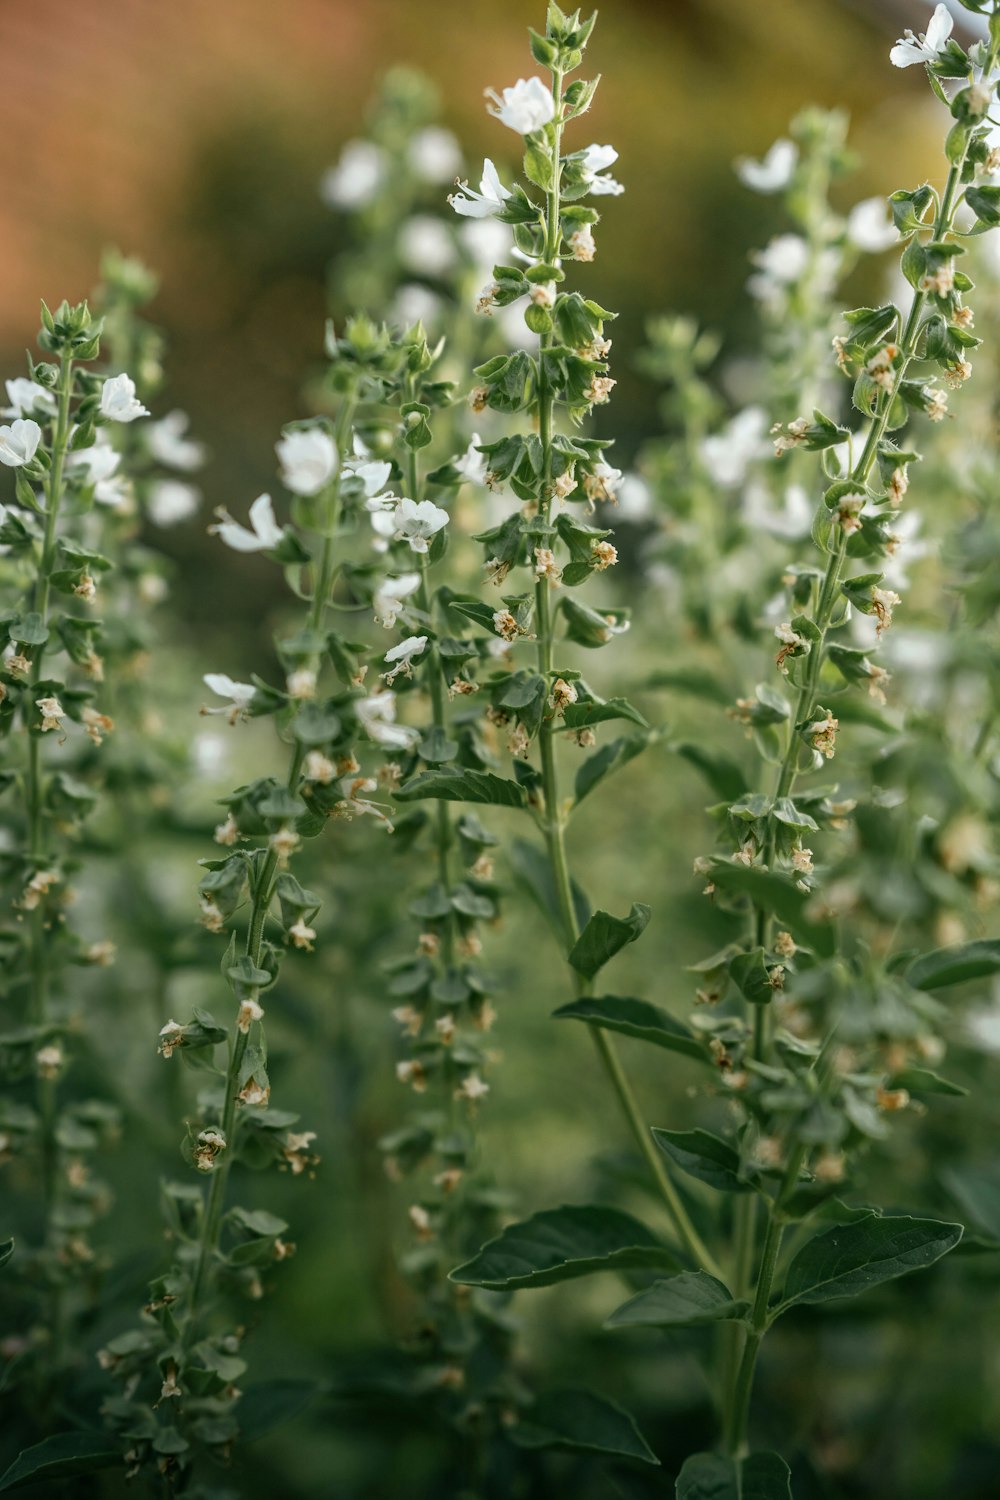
780 1215 963 1313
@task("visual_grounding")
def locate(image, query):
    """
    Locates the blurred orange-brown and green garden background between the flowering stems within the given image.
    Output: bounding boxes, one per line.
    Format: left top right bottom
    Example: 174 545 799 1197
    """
0 0 997 1500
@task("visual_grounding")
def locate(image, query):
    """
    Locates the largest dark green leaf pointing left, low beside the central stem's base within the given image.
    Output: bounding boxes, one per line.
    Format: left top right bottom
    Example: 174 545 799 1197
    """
451 1203 679 1292
